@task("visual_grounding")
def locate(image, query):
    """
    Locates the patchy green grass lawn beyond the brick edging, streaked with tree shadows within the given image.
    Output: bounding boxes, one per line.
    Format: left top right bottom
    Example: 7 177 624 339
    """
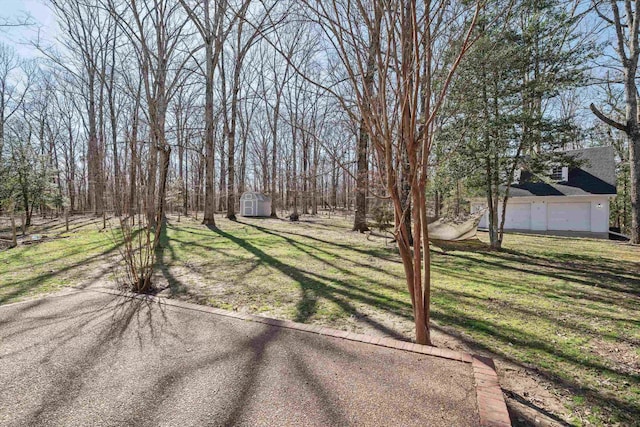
0 217 640 425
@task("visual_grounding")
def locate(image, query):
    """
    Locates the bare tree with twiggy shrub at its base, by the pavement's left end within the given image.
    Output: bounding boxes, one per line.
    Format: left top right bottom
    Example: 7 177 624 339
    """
104 0 193 292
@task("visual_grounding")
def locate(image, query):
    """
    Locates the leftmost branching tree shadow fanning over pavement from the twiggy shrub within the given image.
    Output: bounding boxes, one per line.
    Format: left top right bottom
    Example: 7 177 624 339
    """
3 291 172 425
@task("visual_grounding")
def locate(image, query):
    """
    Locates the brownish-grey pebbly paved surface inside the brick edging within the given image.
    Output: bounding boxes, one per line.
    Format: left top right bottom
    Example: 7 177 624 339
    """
0 291 504 427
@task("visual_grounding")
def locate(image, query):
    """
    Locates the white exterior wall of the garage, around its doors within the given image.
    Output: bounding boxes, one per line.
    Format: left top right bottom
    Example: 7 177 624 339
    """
471 195 612 233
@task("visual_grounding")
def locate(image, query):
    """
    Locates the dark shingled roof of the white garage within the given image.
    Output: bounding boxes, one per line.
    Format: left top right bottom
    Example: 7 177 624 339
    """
509 146 616 197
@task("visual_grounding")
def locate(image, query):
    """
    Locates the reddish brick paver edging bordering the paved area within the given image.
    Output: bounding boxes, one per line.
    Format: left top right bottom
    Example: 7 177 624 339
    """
87 288 511 427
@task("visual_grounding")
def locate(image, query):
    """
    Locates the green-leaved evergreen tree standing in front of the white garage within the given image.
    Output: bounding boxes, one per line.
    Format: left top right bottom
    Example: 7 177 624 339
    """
440 0 592 249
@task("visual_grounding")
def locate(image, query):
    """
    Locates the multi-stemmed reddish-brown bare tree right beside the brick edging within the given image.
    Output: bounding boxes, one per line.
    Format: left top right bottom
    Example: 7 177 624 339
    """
307 0 483 344
